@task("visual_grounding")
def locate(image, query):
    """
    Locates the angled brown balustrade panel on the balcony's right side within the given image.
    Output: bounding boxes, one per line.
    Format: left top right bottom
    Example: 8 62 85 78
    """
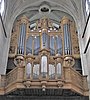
63 67 83 88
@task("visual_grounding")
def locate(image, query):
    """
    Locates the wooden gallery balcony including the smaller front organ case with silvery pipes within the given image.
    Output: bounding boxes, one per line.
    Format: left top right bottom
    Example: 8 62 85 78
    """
0 55 88 96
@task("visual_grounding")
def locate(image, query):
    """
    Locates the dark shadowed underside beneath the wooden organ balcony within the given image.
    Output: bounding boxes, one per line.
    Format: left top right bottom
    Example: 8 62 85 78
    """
0 88 89 100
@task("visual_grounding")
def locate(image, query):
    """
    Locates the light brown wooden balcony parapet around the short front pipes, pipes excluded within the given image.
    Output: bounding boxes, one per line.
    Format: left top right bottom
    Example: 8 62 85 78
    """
0 63 88 96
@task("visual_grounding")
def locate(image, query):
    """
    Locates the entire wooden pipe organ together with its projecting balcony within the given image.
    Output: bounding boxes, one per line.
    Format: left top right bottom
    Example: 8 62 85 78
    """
0 16 88 96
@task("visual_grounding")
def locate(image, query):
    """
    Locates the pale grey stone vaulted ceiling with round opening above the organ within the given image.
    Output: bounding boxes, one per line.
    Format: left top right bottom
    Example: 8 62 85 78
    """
6 0 81 32
